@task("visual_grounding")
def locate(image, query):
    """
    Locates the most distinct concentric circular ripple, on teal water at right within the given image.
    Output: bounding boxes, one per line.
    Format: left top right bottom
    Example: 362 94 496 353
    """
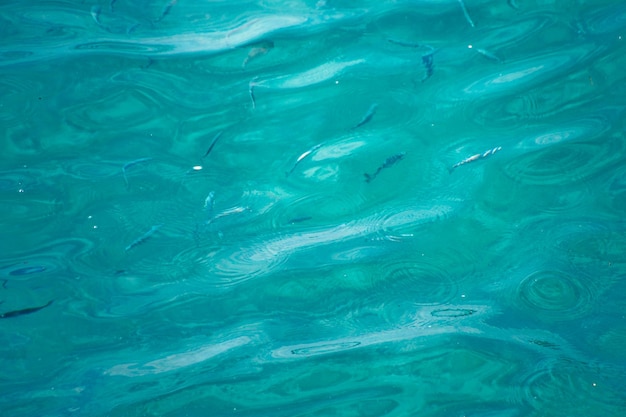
516 270 595 321
